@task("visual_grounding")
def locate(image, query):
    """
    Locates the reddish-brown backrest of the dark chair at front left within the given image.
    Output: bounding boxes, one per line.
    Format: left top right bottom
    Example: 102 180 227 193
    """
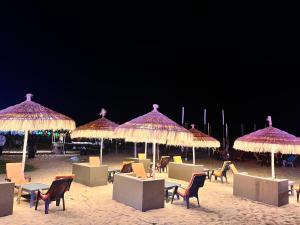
46 178 73 201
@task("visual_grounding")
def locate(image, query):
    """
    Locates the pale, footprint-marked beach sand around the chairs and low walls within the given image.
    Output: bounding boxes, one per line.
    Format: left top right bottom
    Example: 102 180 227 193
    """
0 154 300 225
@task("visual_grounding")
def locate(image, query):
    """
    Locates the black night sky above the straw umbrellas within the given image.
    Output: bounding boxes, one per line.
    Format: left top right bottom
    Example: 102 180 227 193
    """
0 1 300 142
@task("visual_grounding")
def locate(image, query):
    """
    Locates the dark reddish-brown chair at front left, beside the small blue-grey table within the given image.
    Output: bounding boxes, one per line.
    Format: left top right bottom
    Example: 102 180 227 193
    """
35 178 73 214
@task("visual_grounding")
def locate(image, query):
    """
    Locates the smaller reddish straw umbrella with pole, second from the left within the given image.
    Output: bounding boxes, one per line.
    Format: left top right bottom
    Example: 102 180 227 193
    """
71 109 118 163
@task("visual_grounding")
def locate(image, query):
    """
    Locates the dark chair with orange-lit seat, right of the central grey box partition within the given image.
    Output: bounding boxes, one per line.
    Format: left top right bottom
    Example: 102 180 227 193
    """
171 173 206 208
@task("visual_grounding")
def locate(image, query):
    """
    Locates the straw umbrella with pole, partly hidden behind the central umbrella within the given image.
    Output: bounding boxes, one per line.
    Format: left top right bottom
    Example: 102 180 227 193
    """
189 124 220 164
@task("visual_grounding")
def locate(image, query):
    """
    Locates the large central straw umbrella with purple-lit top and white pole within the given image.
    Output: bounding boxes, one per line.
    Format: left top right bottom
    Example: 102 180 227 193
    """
116 104 193 175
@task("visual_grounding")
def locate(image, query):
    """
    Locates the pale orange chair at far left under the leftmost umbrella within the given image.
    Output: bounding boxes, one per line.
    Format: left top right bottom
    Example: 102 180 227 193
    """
5 163 31 186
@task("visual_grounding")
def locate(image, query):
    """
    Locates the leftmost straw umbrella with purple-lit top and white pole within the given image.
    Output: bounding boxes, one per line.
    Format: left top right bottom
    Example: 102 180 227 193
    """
0 94 75 167
